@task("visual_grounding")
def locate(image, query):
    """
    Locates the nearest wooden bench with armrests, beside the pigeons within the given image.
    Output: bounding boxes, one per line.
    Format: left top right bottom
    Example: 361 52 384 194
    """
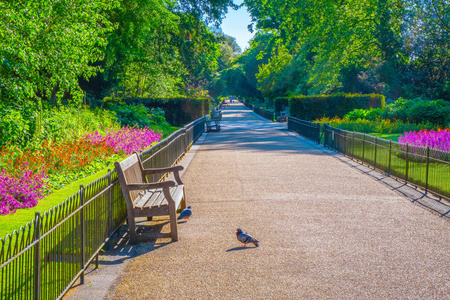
114 153 186 243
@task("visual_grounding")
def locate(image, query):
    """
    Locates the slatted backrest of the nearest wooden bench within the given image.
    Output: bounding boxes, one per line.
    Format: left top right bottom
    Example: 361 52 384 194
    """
114 153 146 208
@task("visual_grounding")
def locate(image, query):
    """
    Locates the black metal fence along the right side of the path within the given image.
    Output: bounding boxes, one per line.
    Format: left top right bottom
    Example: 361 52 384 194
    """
288 117 450 199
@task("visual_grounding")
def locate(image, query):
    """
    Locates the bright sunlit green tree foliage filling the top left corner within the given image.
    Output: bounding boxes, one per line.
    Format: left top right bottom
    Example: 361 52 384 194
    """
0 0 118 102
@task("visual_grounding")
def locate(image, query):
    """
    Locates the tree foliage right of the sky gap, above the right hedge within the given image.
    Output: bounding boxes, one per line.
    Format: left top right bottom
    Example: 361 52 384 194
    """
243 0 450 100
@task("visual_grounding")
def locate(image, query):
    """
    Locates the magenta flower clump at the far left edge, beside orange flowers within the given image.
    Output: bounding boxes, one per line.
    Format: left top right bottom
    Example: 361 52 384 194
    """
0 169 46 215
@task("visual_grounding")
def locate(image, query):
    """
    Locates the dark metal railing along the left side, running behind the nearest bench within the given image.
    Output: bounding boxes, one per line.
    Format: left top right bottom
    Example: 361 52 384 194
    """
0 118 204 299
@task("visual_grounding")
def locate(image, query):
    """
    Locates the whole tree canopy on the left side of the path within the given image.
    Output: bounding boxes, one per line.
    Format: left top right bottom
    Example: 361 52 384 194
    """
0 0 236 104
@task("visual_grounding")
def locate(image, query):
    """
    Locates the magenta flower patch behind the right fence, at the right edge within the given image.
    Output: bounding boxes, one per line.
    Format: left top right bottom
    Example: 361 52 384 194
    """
398 128 450 151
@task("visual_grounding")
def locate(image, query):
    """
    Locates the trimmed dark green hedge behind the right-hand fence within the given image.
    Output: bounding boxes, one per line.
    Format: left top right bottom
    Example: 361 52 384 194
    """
286 94 386 120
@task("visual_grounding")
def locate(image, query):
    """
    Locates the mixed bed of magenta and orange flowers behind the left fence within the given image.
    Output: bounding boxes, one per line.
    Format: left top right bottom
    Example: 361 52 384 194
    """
0 126 161 215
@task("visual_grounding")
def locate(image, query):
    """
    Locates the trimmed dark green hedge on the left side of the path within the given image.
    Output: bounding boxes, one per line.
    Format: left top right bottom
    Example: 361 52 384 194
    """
123 98 211 126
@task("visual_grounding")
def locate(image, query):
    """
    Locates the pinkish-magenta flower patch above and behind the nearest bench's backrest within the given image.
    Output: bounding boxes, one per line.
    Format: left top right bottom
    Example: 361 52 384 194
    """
85 126 162 155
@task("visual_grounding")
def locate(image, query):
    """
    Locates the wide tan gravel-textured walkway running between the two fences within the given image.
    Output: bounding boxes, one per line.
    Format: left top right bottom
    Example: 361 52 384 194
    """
67 104 450 299
